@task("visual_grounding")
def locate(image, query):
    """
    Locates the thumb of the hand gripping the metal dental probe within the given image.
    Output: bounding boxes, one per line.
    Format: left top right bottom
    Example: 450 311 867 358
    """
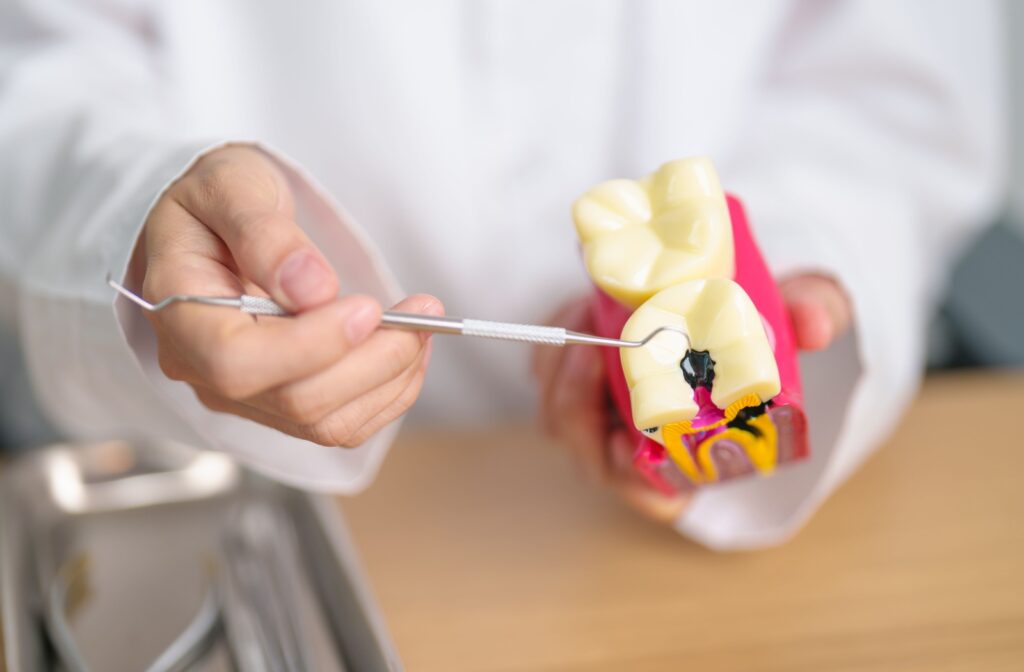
177 148 338 312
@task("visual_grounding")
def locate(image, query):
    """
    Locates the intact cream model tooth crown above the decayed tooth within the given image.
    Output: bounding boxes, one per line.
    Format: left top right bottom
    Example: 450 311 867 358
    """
572 158 733 308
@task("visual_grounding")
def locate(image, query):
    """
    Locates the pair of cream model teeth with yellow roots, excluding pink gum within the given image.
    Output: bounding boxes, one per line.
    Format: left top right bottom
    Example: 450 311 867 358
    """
572 158 780 482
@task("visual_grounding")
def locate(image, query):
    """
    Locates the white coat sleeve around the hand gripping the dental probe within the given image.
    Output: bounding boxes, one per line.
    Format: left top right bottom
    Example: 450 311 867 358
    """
0 0 407 492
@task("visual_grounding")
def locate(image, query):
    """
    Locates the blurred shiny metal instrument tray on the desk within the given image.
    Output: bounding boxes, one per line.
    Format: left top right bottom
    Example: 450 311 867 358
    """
0 442 401 672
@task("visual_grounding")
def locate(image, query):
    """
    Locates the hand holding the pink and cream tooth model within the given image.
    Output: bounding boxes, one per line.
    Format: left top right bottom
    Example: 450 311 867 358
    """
532 275 851 522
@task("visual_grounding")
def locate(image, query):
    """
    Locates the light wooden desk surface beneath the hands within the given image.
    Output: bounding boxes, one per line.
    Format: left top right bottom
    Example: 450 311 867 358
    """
344 374 1024 672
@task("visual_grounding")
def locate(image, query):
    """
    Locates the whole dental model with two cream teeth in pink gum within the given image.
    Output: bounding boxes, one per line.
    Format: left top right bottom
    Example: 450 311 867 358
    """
572 158 807 493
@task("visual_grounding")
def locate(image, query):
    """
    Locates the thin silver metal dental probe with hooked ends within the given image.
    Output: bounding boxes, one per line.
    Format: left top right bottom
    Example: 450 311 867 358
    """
106 276 690 349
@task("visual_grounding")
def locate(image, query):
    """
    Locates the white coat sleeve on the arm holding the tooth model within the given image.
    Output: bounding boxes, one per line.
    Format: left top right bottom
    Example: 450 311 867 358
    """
677 0 1006 549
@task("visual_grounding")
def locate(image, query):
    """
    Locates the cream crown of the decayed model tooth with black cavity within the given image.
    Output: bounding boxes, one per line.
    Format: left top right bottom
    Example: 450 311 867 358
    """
622 279 780 443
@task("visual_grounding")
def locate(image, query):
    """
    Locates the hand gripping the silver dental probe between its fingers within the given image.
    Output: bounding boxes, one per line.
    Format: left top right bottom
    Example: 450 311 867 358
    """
136 146 443 447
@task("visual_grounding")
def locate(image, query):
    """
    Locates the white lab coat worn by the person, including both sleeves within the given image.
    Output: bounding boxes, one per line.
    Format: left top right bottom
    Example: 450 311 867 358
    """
0 0 1004 548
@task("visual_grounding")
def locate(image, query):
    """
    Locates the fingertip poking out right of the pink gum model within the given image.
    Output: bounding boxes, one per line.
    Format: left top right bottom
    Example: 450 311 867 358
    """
779 275 852 350
